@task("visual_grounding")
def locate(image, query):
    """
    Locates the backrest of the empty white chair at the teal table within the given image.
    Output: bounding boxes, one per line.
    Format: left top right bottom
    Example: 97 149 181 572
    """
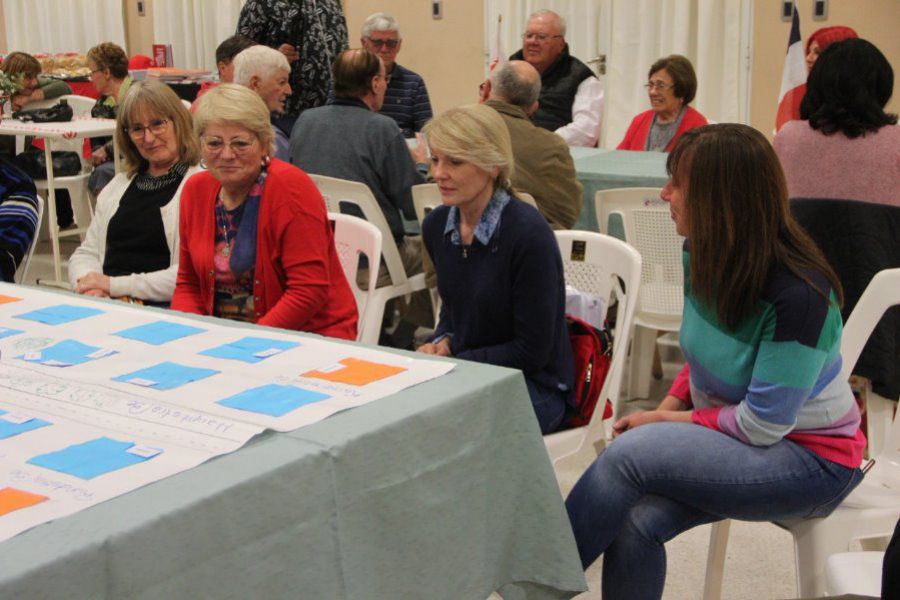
594 188 684 319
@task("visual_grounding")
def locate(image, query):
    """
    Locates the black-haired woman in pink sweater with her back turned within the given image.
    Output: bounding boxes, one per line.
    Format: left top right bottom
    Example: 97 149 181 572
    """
773 39 900 206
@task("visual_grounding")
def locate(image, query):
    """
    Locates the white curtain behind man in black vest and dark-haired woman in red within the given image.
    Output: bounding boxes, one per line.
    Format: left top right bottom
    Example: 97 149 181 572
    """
485 0 752 148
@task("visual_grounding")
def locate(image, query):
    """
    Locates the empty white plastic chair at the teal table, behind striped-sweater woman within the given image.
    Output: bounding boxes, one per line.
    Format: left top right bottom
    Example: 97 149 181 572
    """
594 188 684 398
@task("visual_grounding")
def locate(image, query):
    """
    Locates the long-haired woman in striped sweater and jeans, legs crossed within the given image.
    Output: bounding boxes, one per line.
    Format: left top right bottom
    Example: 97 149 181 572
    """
566 124 865 598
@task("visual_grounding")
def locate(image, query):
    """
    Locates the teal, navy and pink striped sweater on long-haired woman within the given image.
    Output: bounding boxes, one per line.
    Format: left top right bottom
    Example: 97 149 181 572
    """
669 252 866 468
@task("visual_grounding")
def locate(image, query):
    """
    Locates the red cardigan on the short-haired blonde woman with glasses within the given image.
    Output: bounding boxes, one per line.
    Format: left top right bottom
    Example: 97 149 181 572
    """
172 159 357 340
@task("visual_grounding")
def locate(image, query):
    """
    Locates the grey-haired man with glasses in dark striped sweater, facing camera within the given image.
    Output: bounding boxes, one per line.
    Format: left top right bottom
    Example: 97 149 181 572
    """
360 12 432 138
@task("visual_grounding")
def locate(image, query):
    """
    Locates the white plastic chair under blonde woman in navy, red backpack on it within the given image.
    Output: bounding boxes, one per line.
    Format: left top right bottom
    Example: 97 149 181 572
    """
544 231 641 466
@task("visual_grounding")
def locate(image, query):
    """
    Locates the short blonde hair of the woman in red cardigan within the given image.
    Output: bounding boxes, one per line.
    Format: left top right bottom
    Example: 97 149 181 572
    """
194 83 275 155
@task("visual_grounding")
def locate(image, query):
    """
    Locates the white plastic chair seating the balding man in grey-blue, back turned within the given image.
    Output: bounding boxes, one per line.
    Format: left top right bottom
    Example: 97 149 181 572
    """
309 173 425 342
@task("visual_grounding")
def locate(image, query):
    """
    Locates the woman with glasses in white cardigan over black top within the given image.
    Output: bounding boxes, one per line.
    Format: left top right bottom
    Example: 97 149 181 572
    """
69 81 200 304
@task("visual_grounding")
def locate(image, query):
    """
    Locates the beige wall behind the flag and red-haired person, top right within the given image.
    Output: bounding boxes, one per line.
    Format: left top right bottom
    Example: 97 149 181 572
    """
750 0 900 137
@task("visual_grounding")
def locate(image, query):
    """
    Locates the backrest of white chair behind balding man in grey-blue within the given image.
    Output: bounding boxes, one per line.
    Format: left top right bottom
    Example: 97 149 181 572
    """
309 173 407 286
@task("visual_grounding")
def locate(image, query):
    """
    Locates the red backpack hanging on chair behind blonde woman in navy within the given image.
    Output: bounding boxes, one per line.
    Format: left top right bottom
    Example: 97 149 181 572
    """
566 315 612 428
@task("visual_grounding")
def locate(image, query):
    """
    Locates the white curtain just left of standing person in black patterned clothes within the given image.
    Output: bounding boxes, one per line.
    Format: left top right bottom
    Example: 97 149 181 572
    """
153 0 244 71
